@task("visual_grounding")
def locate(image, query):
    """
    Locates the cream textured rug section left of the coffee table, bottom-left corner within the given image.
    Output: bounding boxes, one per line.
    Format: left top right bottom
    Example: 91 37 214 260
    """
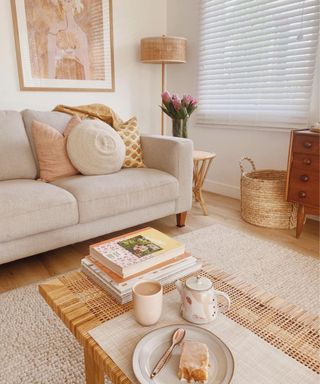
0 285 84 384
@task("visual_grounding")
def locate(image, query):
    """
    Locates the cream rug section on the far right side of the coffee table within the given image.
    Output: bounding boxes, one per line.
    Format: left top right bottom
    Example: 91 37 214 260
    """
178 224 320 313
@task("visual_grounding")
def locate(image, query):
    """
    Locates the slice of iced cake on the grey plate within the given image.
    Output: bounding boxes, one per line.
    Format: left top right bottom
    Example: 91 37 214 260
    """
178 340 209 383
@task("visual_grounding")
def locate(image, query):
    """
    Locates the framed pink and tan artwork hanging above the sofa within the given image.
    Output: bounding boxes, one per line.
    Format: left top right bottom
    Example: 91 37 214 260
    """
11 0 115 92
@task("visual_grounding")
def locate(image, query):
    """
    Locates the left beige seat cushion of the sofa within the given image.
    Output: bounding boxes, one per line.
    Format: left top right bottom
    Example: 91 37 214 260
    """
0 180 79 242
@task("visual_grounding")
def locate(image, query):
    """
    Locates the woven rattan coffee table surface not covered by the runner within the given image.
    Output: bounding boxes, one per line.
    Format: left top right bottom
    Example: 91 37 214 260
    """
39 266 320 384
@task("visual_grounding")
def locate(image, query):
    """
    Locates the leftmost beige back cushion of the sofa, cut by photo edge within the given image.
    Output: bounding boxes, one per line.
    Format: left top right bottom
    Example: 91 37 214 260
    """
0 111 37 180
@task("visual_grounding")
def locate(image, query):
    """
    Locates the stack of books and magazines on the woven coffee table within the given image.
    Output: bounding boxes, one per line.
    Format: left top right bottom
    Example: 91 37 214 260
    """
81 227 201 304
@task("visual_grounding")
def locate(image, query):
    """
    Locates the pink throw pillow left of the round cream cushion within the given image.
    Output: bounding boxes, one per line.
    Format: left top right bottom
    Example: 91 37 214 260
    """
32 116 81 182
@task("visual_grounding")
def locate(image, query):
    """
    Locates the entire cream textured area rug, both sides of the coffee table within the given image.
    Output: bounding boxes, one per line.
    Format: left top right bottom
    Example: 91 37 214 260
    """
0 220 320 384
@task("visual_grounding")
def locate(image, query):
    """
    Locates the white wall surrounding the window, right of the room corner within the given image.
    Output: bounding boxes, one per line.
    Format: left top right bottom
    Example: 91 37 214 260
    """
167 0 302 197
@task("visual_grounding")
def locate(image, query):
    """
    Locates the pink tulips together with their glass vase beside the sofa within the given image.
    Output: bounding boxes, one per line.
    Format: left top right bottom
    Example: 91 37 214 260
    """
160 91 198 138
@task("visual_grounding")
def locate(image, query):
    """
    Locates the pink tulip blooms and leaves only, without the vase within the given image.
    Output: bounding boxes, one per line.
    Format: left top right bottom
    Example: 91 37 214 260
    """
161 91 198 119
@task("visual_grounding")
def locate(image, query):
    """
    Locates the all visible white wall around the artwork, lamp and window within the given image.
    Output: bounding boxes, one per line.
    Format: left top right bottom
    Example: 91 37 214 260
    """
0 0 316 197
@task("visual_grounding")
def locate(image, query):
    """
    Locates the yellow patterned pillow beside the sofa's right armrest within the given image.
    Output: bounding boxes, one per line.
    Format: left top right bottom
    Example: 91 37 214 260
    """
114 117 145 168
